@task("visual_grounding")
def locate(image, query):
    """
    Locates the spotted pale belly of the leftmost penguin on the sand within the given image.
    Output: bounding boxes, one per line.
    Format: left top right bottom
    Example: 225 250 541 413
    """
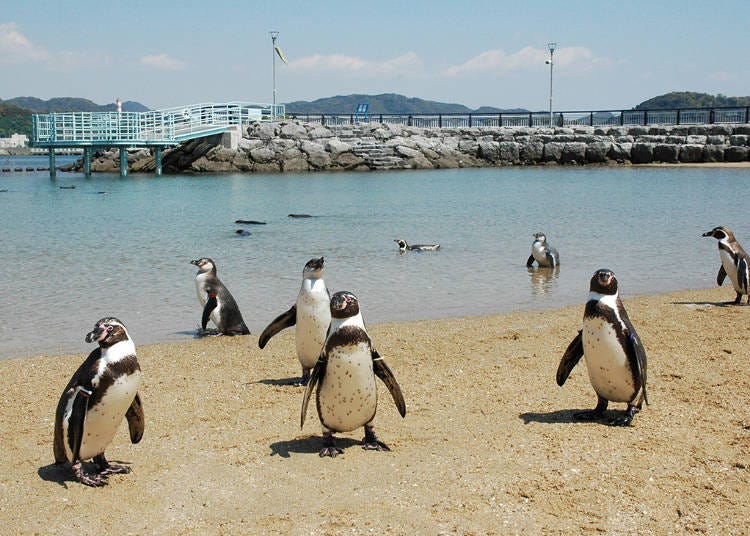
76 371 141 460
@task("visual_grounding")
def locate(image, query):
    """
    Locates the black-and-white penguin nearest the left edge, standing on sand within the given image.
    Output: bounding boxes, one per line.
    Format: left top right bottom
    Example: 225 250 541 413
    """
54 317 145 487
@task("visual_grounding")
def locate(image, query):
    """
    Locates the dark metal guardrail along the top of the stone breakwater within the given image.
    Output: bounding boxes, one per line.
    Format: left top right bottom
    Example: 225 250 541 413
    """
288 106 750 128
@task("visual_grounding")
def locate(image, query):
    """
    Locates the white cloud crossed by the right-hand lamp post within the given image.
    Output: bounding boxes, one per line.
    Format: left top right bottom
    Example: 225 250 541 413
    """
443 47 610 77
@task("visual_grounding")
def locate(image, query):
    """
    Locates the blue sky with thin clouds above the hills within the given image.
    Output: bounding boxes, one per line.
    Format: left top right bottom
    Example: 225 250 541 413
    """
0 0 750 112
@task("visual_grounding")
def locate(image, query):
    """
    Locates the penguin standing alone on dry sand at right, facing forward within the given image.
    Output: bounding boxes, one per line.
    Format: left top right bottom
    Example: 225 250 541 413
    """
557 269 648 426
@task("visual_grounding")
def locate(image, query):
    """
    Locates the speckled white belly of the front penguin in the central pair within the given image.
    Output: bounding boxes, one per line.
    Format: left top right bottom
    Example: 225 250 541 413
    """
318 343 378 432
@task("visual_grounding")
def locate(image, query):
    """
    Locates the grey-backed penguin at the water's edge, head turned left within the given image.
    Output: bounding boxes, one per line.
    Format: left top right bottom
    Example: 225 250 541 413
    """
190 257 250 335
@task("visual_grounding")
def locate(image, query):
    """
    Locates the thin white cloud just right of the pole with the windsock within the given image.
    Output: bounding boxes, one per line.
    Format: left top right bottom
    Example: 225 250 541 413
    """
289 52 423 76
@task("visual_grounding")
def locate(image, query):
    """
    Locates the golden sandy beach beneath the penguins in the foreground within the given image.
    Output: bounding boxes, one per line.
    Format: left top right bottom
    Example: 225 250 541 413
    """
0 287 750 534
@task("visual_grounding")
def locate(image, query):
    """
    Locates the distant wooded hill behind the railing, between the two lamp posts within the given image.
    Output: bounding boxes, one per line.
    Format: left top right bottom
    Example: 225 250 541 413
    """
285 93 528 115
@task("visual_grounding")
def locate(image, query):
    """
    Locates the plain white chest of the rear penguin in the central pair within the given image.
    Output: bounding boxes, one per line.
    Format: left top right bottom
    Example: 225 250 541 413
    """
294 285 331 368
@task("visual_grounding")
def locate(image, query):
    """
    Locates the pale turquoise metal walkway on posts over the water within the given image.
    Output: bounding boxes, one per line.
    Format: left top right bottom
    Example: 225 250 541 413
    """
30 102 284 176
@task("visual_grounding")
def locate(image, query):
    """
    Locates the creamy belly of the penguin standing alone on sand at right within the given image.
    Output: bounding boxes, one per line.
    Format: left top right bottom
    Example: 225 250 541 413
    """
583 317 637 402
